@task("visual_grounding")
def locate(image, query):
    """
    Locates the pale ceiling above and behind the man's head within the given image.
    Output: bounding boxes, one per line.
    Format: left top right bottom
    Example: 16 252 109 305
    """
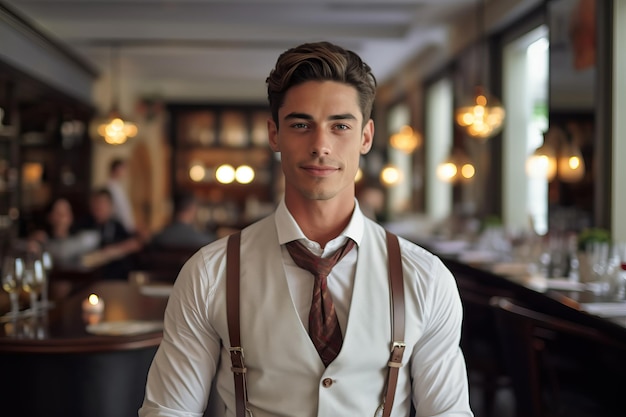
2 0 478 101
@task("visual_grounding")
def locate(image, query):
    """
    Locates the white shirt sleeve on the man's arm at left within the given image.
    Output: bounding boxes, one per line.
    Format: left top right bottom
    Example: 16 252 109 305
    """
139 245 220 417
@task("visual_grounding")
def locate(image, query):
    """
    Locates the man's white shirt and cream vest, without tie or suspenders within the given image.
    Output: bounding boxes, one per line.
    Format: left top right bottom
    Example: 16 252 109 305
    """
139 202 472 417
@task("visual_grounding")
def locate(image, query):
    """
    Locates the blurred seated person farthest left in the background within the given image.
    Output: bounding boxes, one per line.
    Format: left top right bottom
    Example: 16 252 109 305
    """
31 197 100 267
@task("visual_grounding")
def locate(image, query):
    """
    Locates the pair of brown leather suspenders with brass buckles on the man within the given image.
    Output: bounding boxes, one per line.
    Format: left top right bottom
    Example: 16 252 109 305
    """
226 231 406 417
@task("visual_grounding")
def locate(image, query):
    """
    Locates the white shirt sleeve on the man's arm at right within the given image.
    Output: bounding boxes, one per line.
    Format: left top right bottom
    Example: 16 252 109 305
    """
411 258 473 417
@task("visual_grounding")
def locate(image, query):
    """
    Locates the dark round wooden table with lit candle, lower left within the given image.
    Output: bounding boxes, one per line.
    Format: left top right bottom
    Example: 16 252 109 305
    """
0 280 171 417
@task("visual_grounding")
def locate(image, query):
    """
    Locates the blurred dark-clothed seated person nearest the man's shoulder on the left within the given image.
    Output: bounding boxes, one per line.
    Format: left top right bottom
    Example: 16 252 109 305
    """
151 192 215 250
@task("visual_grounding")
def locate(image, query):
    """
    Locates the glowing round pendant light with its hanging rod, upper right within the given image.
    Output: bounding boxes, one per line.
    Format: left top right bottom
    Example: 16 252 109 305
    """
455 0 506 141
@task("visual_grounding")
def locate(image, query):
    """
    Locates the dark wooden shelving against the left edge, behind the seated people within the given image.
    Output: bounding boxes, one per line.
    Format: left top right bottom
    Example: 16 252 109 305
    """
0 62 94 237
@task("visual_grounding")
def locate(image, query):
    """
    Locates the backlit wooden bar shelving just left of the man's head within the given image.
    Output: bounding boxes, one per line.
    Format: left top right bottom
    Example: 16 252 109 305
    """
168 105 280 228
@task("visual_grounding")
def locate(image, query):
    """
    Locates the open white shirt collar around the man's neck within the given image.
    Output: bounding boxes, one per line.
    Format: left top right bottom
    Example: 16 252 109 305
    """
274 198 365 252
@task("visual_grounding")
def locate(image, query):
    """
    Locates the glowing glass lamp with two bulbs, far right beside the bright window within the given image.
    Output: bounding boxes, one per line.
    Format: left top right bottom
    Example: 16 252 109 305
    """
526 127 585 183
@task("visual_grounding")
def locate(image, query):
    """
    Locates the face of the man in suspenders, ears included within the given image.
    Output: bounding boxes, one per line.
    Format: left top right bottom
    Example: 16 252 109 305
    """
268 81 374 202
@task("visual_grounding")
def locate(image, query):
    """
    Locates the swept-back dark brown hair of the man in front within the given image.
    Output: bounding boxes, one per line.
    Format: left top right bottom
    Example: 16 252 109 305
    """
266 42 376 126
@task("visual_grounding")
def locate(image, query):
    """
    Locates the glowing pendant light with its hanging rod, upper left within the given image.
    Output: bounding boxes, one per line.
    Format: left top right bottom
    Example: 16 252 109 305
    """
94 46 137 145
